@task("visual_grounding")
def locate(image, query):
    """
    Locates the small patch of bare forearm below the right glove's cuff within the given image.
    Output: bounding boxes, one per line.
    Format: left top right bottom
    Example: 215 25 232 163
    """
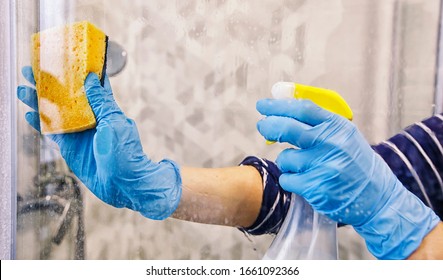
408 222 443 260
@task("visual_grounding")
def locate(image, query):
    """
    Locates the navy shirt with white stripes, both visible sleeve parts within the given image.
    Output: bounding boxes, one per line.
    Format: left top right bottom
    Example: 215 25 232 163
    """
240 114 443 235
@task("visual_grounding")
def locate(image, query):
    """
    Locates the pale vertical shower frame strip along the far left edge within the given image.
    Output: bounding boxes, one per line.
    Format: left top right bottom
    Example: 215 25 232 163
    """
0 0 17 260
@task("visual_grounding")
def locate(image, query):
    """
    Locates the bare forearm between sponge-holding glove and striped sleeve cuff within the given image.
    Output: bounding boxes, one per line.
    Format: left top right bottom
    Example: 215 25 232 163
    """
172 166 263 227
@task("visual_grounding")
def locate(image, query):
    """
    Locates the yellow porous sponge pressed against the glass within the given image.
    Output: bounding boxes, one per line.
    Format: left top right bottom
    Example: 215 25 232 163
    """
32 21 107 134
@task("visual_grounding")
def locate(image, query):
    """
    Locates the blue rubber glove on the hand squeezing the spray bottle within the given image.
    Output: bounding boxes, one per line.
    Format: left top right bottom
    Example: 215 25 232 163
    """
257 99 439 259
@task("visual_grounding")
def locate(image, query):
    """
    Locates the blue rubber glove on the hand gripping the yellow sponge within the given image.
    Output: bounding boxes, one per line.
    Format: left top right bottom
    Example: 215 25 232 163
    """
17 67 182 220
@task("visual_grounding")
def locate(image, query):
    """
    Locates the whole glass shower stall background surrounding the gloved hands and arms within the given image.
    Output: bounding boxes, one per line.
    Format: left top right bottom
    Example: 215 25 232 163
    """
0 0 443 259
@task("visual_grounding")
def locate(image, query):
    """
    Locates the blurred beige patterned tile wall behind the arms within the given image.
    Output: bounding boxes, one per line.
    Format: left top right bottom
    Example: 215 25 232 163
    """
18 0 439 259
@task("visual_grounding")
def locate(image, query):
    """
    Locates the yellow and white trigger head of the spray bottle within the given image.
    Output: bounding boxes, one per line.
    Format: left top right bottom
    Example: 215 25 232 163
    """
266 82 353 144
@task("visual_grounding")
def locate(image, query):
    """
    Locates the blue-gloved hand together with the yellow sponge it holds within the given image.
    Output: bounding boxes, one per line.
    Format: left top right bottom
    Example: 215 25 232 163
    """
17 20 182 220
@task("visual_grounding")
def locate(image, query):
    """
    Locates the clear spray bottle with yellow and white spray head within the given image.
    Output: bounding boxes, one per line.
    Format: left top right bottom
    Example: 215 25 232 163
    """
263 82 353 260
